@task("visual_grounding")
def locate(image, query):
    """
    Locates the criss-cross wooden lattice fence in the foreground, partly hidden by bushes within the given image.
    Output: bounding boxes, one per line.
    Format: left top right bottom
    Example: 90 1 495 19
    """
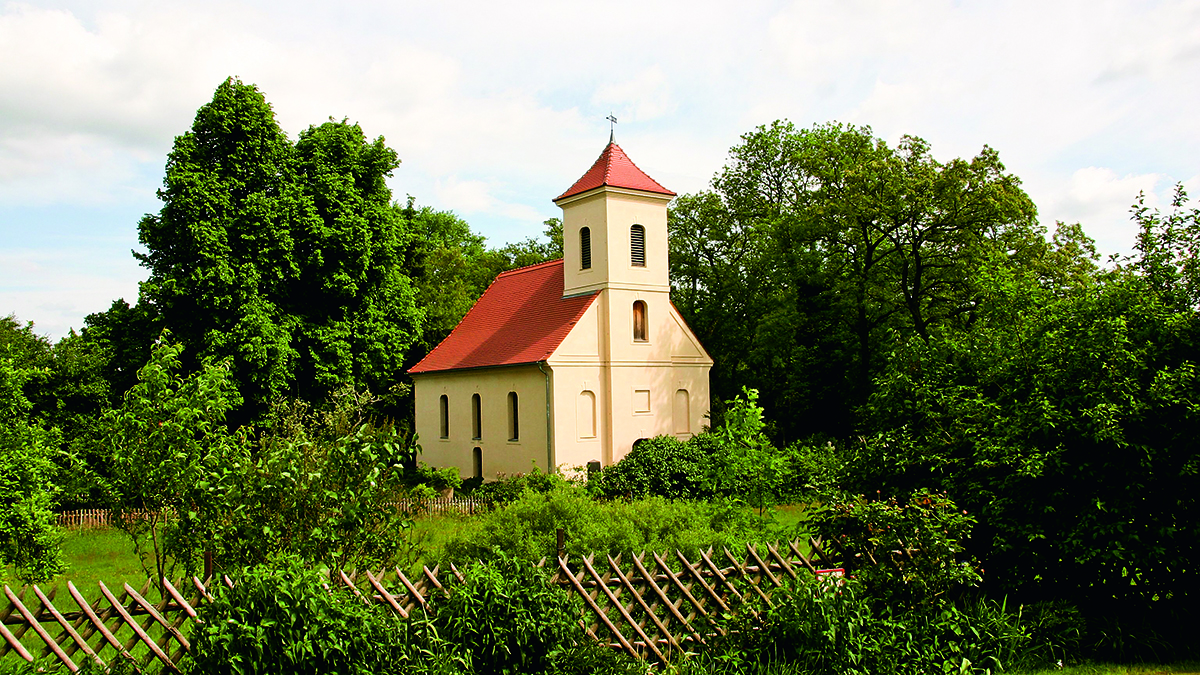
0 538 841 673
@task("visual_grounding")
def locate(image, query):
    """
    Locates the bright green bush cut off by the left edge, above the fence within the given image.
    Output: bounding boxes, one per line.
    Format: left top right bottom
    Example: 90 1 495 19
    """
0 344 62 581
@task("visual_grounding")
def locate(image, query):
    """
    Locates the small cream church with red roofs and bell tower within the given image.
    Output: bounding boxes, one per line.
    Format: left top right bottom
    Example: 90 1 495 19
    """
408 139 713 479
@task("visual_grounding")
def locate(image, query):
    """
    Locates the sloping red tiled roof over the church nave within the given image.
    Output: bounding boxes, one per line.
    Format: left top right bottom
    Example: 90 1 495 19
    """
408 259 599 374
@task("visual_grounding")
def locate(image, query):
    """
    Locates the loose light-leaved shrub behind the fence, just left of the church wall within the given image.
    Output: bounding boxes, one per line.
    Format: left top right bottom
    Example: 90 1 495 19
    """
206 392 427 569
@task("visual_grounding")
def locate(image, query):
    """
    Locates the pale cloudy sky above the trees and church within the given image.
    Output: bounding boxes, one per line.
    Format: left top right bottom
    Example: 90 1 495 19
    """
0 0 1200 340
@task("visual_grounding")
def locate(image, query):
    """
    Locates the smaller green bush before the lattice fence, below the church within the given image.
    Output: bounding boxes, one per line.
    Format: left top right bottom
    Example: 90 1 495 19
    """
433 554 638 674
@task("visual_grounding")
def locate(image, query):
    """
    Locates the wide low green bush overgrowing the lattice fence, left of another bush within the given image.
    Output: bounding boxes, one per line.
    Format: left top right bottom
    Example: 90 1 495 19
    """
186 556 467 675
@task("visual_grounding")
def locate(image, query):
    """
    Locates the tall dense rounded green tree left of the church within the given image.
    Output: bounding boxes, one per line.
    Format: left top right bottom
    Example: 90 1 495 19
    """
138 79 421 418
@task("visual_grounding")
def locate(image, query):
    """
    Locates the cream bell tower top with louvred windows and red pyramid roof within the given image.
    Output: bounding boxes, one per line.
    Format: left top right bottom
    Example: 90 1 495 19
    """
554 141 674 297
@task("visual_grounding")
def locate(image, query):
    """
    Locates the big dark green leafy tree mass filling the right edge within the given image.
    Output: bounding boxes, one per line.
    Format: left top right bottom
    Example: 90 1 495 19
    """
857 186 1200 625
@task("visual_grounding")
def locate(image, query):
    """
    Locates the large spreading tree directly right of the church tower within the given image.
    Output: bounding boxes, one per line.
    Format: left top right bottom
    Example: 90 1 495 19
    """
671 123 1045 437
